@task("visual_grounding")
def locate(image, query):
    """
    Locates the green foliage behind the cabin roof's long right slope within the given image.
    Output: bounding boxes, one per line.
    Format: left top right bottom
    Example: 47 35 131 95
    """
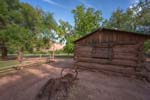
103 0 150 33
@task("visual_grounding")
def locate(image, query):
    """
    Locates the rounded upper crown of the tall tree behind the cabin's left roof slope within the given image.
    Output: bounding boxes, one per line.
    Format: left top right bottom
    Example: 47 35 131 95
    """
72 5 102 36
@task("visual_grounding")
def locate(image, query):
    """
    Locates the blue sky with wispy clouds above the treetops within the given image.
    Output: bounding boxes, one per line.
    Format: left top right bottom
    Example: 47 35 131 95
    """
21 0 138 25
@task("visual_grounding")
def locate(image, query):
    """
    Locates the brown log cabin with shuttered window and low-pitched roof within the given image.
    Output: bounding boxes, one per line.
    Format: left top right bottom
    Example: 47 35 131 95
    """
74 28 150 75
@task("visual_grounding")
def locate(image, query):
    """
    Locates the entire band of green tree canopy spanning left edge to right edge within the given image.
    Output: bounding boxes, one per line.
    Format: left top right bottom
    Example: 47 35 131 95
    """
0 0 150 57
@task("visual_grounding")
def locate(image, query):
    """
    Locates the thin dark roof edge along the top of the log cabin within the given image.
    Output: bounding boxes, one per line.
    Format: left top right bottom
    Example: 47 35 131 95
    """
74 28 150 43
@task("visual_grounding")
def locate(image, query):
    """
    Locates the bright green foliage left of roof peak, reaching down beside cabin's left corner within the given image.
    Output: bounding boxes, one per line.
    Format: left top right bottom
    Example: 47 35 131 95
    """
60 5 102 54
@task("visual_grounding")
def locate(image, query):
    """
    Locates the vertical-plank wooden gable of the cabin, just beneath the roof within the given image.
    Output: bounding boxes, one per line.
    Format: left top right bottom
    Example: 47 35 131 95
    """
76 31 145 45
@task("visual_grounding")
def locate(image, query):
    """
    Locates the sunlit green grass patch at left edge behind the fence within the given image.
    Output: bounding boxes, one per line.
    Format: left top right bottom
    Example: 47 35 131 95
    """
0 60 19 68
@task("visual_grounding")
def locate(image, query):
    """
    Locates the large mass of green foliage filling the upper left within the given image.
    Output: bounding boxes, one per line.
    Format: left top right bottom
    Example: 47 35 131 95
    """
0 0 57 55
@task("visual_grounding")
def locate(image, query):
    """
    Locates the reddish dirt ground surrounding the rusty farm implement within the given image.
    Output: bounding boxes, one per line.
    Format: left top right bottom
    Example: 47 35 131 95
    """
0 59 150 100
